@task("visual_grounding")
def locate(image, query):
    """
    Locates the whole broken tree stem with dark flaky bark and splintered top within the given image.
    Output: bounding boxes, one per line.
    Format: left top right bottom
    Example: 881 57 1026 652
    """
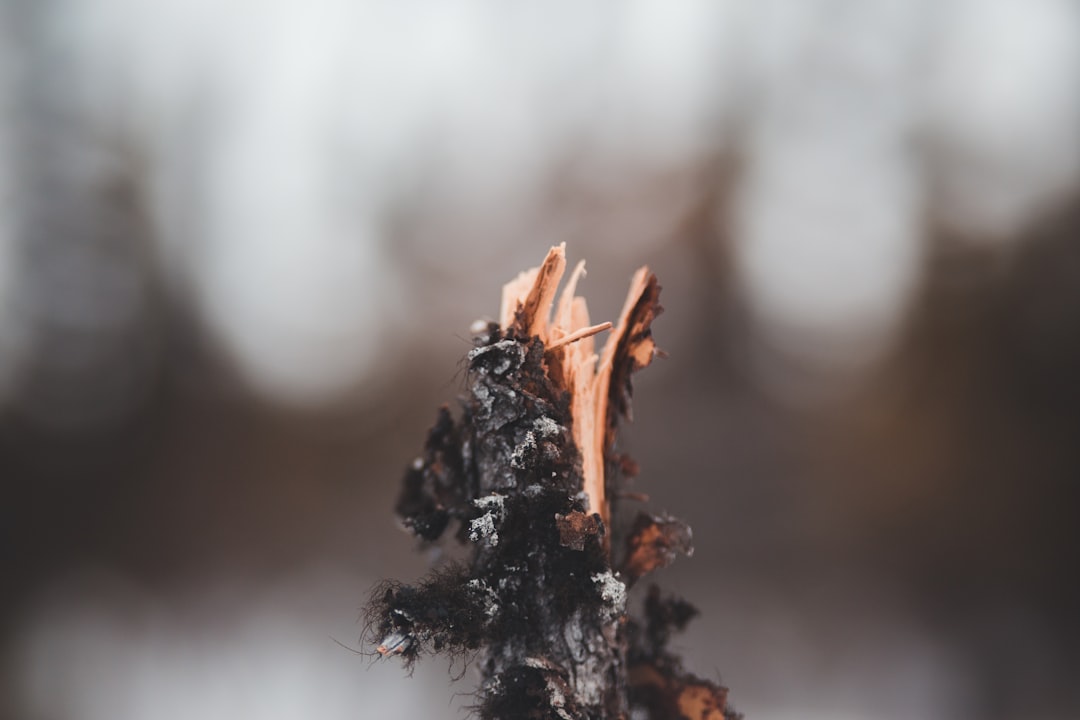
367 245 738 720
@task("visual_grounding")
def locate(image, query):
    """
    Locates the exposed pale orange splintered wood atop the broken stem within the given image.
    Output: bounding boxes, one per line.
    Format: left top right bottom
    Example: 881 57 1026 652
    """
500 243 659 533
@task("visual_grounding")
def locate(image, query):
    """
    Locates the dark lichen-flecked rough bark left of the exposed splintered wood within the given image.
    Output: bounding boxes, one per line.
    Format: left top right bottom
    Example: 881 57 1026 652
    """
372 325 626 718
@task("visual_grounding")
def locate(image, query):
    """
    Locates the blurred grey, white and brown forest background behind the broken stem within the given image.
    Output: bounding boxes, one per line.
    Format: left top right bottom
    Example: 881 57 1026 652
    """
0 0 1080 720
